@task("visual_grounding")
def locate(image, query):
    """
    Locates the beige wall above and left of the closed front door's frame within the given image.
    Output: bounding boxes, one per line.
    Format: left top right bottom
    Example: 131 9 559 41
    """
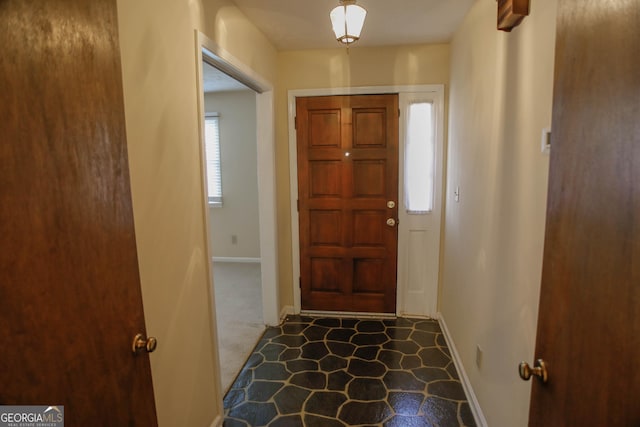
275 44 449 307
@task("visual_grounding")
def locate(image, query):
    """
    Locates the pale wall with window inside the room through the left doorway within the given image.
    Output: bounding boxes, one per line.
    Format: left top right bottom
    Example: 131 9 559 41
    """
204 90 260 258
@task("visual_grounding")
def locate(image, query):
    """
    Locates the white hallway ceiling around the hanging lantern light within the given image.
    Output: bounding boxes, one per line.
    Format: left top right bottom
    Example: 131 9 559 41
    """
233 0 475 50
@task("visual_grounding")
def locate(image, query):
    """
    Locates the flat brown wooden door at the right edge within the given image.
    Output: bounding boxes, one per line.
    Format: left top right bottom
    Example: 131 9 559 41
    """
529 0 640 427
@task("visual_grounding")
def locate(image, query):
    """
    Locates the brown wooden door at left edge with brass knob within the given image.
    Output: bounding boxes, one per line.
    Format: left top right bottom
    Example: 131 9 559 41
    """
0 0 157 427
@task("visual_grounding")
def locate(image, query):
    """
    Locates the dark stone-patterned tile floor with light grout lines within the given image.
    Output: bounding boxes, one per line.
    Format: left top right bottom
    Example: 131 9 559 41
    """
224 316 475 427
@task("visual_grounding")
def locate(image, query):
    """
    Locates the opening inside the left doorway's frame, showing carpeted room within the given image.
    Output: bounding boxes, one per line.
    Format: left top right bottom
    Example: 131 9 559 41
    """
202 61 265 390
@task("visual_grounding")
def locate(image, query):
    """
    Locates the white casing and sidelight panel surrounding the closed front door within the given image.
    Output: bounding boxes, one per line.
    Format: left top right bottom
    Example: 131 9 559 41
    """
288 85 444 318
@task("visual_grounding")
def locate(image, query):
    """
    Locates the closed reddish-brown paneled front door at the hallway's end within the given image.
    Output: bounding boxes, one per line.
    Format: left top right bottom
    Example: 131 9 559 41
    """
296 95 398 313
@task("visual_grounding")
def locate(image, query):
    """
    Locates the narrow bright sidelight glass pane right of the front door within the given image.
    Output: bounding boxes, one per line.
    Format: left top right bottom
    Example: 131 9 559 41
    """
404 102 436 214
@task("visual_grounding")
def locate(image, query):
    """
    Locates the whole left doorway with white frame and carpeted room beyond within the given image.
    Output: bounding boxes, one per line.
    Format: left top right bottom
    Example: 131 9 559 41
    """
196 32 279 393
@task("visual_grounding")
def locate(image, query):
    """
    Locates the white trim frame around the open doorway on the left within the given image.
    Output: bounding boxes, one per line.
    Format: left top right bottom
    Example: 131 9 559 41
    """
195 30 280 328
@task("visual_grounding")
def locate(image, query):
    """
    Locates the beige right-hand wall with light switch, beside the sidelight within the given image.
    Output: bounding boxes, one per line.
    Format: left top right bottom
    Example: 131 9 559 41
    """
440 0 557 427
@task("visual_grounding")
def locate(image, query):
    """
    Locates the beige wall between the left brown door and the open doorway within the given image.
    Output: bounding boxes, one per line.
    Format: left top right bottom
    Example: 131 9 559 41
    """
118 0 276 427
